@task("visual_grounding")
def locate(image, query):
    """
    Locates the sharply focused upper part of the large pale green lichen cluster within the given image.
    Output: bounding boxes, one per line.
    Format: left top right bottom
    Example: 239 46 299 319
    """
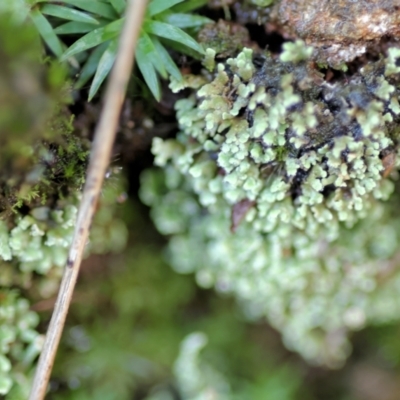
153 43 398 242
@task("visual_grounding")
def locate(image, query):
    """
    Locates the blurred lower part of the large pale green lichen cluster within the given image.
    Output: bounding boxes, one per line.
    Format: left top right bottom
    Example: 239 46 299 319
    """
142 167 400 367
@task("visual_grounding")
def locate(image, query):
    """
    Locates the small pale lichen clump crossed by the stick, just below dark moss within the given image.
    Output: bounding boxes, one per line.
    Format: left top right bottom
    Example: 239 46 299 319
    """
0 173 128 286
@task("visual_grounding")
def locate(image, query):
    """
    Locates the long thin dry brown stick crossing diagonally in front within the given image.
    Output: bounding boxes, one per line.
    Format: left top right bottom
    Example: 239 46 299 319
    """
29 0 147 400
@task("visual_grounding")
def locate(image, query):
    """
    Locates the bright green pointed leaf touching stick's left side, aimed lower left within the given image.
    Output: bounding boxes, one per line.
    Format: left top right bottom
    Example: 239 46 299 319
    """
61 18 124 60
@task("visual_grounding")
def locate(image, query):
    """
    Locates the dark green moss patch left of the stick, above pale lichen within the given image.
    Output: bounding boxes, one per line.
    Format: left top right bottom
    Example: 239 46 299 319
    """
0 14 88 219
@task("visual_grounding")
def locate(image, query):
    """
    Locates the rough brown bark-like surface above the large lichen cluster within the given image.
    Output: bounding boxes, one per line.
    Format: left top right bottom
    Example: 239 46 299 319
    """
271 0 400 66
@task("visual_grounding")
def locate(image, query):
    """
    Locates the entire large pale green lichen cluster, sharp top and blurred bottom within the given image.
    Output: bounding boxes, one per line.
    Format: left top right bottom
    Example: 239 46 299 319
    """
142 41 400 366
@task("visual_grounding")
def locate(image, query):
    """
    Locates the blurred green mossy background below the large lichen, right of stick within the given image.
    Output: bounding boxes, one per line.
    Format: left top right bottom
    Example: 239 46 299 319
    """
39 198 400 400
